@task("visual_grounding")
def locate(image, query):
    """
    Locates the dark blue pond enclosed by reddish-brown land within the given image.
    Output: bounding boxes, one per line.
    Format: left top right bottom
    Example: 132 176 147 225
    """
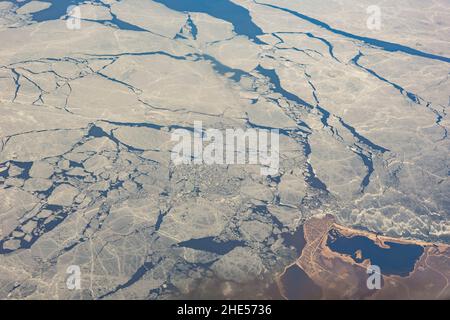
327 230 424 277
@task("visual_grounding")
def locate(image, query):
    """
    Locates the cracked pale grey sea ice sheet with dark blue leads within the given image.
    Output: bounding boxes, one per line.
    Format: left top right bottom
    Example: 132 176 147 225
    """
0 0 450 299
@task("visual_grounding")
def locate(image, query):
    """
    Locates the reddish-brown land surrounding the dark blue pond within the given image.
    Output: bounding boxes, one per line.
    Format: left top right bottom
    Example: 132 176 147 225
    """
279 216 450 299
